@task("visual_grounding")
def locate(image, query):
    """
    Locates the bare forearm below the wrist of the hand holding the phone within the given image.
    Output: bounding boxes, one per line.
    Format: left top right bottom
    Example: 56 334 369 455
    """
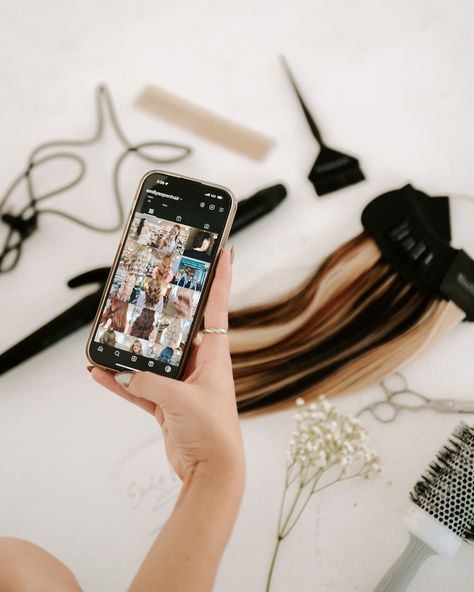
130 465 244 592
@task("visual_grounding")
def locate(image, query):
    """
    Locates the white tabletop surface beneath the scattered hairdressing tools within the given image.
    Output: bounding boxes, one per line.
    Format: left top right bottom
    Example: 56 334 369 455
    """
0 0 474 592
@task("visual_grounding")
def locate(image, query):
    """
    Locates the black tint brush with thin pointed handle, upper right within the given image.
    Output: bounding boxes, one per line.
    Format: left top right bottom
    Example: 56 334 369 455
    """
280 56 365 195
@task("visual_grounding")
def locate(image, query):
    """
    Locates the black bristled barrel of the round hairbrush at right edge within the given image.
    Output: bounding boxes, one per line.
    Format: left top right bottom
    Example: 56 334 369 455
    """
410 423 474 541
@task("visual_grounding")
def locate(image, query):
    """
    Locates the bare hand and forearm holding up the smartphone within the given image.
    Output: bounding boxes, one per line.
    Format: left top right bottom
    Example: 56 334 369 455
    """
91 246 245 592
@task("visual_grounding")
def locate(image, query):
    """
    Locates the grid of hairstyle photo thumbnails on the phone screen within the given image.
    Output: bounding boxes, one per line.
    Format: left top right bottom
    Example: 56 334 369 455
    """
94 213 213 366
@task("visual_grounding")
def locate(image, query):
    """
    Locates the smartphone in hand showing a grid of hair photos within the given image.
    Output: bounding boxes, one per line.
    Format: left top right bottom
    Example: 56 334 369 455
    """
86 171 237 378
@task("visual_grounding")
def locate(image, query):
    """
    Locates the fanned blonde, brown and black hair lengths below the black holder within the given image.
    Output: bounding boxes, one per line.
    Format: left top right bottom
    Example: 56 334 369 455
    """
229 232 465 412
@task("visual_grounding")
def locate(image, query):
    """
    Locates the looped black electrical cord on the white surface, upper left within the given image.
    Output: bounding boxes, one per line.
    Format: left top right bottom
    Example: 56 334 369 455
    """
0 84 192 273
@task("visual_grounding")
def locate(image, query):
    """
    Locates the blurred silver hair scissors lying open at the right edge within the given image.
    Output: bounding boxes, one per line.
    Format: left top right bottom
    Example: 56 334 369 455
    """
357 372 474 423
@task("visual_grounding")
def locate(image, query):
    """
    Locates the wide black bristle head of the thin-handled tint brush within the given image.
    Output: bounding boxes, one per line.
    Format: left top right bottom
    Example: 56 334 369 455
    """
308 146 365 195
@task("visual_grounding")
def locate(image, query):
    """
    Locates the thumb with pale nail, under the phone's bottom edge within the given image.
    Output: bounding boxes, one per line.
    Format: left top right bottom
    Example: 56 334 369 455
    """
114 372 177 409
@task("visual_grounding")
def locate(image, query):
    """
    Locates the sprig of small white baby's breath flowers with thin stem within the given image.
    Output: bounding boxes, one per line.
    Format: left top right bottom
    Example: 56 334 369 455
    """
266 396 380 592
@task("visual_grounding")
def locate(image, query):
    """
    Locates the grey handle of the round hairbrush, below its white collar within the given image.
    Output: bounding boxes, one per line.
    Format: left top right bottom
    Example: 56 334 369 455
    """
374 533 434 592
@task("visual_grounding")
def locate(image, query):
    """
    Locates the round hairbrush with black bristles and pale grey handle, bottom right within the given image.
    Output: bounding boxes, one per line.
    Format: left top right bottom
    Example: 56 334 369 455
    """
374 423 474 592
